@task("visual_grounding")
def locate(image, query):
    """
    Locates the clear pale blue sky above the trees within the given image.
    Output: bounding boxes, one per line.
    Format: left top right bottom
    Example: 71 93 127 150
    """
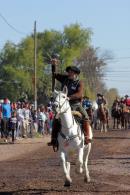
0 0 130 96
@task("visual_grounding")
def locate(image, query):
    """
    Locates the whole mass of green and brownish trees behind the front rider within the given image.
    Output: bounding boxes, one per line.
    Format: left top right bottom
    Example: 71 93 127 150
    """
0 24 110 103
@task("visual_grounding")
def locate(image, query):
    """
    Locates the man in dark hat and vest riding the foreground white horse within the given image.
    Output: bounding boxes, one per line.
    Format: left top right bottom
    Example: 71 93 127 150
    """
48 62 90 147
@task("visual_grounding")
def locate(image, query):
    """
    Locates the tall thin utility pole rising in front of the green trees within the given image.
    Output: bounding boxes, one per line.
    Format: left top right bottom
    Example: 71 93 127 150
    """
34 21 37 110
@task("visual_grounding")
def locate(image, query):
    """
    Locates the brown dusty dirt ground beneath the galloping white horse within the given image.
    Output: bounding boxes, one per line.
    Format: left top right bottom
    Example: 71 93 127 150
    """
0 130 130 195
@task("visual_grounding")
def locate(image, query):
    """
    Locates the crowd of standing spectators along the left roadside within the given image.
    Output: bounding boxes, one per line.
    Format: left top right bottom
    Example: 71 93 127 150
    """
0 98 54 142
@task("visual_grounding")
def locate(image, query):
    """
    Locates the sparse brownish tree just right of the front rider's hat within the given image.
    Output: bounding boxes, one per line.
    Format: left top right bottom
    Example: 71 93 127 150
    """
76 47 109 98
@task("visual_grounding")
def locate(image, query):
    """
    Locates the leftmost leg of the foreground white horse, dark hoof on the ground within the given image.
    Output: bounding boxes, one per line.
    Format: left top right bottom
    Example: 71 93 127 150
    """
61 152 72 186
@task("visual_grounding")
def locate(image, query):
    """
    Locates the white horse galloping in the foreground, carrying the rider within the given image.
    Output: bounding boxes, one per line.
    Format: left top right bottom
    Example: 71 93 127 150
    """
54 88 93 186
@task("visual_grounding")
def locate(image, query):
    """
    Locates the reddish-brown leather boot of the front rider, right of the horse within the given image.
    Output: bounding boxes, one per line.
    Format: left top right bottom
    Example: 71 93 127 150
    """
83 120 91 144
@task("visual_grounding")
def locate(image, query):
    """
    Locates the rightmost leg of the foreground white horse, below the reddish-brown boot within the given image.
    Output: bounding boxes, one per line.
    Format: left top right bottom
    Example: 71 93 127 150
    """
84 143 91 183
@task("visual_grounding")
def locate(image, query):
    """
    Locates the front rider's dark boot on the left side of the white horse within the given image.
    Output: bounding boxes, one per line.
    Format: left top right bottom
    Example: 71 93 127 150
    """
48 119 61 146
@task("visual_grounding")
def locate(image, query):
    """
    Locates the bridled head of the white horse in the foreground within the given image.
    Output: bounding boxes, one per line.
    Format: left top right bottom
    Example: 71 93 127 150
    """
53 87 70 114
